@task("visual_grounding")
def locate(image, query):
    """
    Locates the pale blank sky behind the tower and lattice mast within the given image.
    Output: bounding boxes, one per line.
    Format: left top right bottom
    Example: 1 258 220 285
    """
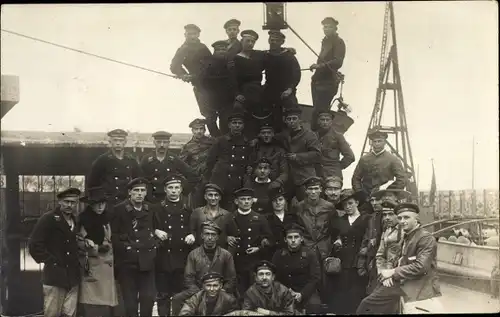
1 1 499 190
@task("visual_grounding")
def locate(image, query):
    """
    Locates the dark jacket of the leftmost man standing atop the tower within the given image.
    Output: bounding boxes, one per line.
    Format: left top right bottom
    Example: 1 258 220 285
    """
170 41 212 86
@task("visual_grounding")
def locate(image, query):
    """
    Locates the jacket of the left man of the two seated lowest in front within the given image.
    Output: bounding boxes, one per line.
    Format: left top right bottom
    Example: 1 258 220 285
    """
179 290 239 316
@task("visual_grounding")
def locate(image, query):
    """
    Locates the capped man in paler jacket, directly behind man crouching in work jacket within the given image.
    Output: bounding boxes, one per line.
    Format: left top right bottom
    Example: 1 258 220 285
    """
189 183 229 248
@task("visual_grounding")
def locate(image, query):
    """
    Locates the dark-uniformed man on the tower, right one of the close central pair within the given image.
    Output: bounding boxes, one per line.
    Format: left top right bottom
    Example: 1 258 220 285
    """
263 30 301 133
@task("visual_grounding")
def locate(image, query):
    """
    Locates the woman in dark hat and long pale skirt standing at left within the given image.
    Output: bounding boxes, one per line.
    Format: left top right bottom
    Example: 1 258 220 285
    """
79 187 118 317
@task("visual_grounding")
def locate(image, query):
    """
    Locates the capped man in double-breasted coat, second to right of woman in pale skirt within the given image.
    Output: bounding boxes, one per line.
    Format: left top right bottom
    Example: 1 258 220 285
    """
154 173 195 316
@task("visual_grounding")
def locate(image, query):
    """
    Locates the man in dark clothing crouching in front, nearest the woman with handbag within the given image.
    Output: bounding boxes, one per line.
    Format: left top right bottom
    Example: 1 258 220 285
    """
272 223 321 314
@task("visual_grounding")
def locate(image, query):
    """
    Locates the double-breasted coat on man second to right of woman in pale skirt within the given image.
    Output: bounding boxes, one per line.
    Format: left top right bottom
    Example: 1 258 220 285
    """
155 199 192 272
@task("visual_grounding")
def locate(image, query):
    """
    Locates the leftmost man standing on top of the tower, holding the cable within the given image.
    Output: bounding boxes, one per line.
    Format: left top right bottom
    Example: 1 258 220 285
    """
170 24 212 122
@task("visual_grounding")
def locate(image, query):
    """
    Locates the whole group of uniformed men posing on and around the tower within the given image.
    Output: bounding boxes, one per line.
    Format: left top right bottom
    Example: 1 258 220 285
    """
30 18 439 316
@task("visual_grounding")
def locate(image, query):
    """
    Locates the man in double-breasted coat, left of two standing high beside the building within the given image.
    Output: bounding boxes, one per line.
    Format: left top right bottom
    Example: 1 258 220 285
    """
85 129 141 206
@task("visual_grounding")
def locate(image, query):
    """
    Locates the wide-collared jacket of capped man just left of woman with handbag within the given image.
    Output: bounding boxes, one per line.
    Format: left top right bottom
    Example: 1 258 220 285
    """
295 198 337 259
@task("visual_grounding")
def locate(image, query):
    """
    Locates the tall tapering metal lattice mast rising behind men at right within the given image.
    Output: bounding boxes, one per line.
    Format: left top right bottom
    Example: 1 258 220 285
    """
361 1 418 199
